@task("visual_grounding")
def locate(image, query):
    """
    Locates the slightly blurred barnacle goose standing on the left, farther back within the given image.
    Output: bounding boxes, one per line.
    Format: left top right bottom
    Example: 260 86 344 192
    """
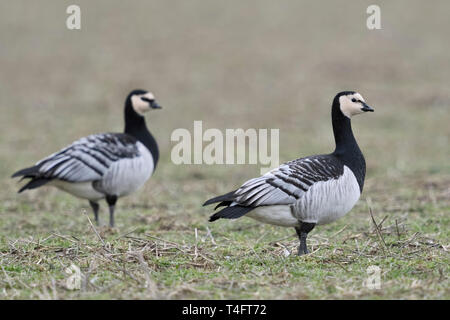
12 90 161 227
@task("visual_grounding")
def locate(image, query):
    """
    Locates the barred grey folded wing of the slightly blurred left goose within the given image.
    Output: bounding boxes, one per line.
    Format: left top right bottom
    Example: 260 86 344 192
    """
35 133 139 182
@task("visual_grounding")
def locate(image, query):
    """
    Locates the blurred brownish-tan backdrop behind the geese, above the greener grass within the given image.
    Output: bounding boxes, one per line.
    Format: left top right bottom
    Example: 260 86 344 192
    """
0 0 450 176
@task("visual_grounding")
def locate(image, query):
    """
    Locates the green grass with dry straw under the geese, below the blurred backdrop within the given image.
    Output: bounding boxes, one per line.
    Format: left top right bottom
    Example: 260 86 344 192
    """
0 171 450 299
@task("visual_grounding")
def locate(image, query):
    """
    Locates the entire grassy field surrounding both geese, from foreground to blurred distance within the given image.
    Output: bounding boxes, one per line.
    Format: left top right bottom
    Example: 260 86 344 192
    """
0 0 450 299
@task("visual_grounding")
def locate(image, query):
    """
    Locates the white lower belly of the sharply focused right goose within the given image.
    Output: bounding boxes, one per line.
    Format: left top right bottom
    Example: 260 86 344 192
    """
246 205 299 227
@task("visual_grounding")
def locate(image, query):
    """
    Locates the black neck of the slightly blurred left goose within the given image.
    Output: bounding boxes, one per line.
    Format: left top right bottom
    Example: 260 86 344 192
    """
124 99 159 168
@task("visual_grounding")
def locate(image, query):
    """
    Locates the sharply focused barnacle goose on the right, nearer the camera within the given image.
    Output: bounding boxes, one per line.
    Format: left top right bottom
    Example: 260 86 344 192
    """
204 91 374 255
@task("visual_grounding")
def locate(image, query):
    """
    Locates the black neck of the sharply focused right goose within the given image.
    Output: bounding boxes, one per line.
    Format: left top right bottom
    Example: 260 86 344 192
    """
331 102 366 192
